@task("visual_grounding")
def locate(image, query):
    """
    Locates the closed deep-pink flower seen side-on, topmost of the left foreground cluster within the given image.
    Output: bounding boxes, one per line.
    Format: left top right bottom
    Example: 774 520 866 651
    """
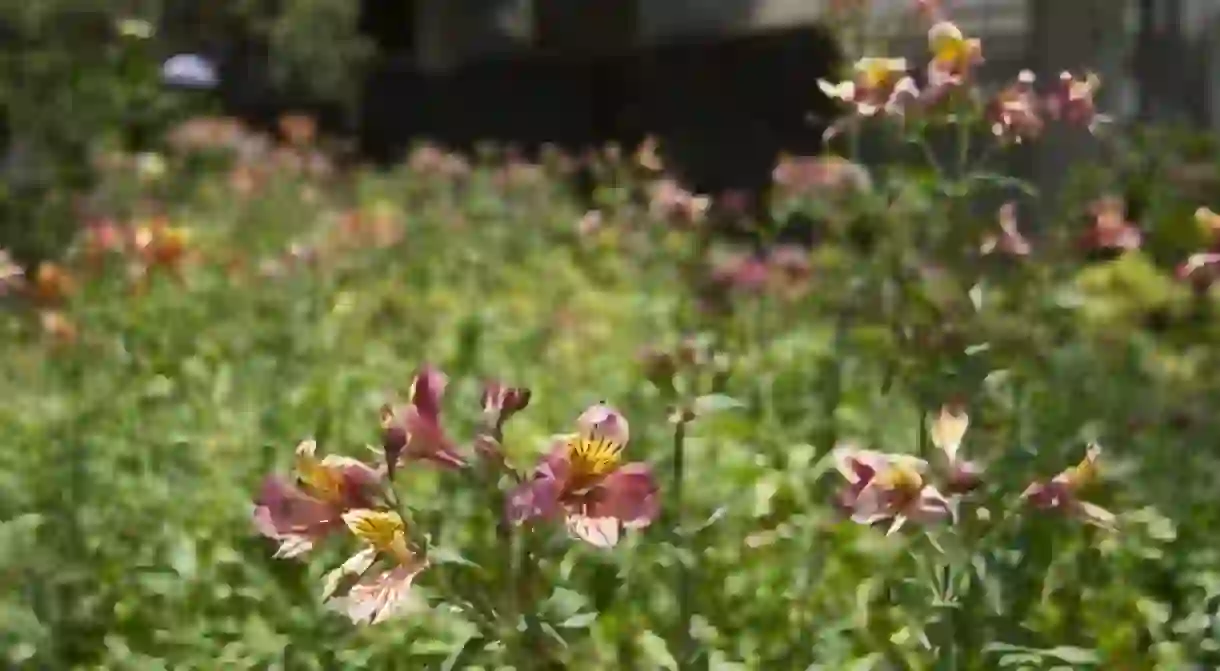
382 366 466 478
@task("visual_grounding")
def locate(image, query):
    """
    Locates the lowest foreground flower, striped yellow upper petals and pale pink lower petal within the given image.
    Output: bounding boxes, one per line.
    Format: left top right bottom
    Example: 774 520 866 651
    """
322 509 428 625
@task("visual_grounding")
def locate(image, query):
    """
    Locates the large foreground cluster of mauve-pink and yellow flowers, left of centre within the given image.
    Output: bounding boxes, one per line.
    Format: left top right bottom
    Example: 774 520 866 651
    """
253 366 659 623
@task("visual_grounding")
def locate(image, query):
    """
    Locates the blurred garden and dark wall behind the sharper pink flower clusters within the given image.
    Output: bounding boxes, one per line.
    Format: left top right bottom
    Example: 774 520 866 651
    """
7 0 1220 671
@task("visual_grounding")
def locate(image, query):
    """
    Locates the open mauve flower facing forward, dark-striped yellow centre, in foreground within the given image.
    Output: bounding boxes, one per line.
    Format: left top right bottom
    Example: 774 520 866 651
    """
506 403 660 548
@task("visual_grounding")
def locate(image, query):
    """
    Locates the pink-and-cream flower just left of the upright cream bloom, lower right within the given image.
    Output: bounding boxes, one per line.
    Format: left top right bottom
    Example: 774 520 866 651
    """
833 445 954 536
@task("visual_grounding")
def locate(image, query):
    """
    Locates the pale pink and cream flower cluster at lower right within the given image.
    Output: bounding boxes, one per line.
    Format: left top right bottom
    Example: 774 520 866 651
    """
833 405 1115 534
